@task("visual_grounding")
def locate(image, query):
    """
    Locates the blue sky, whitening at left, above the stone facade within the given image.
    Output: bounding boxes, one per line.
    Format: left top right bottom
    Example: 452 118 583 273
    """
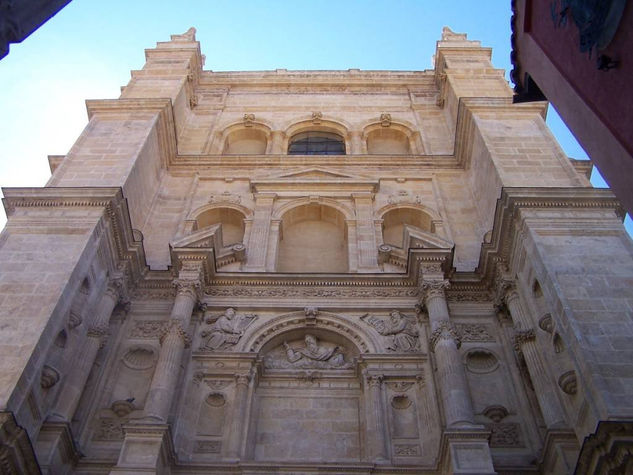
0 0 630 233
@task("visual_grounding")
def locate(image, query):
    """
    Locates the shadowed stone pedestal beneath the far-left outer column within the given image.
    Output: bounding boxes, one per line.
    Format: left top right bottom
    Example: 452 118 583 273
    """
35 420 81 475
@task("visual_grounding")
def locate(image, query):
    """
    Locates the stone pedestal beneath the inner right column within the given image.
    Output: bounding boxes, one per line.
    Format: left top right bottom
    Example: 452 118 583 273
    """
442 429 497 475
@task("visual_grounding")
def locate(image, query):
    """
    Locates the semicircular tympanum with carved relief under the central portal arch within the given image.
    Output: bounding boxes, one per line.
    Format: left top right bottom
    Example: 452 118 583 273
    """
259 327 360 371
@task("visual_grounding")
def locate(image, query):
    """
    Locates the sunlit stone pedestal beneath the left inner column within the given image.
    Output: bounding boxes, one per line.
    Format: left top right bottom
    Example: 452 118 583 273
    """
110 423 175 475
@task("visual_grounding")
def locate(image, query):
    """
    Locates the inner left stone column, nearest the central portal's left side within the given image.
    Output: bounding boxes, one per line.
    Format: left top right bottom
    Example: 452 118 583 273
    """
145 278 200 422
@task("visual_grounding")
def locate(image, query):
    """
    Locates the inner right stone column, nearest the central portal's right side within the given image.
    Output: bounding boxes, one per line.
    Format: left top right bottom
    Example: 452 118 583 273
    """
423 280 475 427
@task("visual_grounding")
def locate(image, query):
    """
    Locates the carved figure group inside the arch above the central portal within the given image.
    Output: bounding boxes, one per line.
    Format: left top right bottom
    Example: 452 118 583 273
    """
265 333 352 369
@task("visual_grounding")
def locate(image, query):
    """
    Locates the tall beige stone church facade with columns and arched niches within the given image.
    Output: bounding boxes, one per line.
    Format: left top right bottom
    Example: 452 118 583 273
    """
0 29 633 474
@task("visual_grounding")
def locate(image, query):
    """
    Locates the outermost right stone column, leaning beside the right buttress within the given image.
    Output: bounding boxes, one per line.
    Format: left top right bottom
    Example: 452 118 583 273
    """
504 285 565 429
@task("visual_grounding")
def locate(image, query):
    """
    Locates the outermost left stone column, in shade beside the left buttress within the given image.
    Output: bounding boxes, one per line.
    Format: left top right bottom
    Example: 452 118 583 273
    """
52 279 123 422
